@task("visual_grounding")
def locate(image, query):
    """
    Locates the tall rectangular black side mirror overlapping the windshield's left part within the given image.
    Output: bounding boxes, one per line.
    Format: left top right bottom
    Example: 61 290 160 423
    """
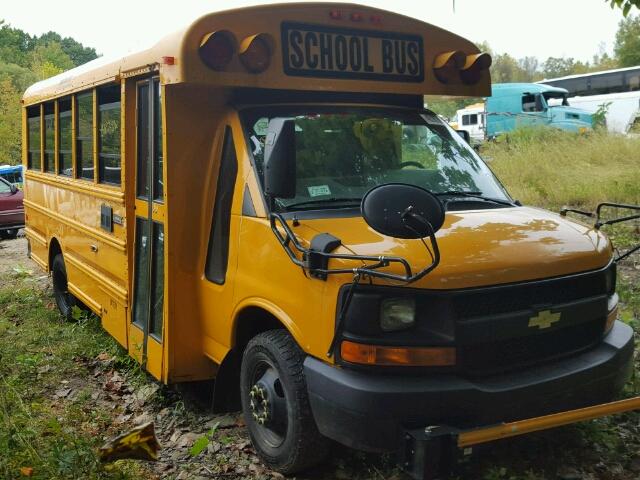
264 118 296 198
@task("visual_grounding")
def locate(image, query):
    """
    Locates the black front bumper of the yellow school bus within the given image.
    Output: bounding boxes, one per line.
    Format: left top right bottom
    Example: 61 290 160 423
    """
304 322 633 451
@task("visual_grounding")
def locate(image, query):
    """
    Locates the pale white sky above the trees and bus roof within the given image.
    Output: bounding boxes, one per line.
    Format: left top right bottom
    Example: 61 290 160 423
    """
0 0 623 61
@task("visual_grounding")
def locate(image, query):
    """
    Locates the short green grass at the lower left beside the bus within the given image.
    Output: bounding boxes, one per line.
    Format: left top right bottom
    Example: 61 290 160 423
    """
0 273 151 479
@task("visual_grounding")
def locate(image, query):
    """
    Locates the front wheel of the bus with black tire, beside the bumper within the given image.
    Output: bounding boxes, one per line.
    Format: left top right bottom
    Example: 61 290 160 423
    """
240 330 330 475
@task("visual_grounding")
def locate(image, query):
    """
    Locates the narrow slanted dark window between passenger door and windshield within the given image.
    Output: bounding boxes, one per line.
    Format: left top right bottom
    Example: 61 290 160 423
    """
204 126 238 285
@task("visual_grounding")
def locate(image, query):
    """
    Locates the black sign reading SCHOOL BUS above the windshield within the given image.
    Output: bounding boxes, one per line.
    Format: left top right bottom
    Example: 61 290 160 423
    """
281 22 424 82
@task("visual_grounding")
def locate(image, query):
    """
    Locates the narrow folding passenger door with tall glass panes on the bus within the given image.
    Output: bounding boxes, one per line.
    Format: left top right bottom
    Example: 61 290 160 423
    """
129 77 166 379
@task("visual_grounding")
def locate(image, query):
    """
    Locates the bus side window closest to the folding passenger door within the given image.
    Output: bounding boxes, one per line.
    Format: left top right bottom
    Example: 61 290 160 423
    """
98 85 122 185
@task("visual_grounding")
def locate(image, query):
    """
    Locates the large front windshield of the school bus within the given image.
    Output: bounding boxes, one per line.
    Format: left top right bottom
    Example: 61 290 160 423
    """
243 107 509 211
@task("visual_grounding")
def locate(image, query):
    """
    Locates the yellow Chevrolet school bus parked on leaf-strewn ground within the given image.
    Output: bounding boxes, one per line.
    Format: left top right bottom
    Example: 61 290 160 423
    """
23 3 637 477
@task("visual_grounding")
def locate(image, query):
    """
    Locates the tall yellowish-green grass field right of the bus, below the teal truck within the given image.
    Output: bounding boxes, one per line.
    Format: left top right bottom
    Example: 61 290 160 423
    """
481 128 640 210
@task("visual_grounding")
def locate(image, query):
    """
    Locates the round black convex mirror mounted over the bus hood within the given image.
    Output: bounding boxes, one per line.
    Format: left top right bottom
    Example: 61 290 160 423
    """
360 183 444 239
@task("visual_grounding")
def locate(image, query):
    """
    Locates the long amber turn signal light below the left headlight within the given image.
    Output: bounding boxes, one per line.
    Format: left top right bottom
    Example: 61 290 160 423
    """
340 340 456 367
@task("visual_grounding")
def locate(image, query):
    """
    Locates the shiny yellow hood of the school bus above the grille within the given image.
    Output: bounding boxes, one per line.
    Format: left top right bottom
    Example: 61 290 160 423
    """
296 207 612 289
